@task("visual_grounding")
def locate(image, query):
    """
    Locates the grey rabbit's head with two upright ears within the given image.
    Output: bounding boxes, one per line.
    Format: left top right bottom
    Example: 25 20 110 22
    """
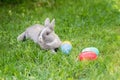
39 18 55 43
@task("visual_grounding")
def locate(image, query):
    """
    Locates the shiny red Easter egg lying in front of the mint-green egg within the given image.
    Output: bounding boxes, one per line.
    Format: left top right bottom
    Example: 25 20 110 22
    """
79 51 97 61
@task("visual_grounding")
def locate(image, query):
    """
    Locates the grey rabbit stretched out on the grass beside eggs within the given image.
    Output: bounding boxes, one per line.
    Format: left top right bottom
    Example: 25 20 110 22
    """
17 18 62 53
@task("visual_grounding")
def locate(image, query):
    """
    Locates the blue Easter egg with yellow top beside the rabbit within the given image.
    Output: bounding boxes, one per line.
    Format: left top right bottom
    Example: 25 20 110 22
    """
60 42 72 54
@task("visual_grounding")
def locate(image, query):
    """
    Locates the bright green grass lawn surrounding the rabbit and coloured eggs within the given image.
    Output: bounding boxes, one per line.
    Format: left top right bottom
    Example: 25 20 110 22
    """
0 0 120 80
